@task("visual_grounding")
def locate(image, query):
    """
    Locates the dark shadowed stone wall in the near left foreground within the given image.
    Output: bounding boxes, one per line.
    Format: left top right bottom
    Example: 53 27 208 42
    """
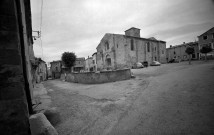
0 0 30 135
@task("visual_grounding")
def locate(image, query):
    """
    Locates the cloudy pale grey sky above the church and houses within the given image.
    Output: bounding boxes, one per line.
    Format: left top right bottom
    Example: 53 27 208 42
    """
31 0 214 62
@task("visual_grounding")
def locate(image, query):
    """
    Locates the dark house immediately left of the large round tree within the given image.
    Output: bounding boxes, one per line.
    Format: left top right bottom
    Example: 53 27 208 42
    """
50 60 62 79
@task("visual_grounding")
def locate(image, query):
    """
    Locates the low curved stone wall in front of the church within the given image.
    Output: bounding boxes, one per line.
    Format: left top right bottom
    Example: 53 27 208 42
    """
61 69 131 84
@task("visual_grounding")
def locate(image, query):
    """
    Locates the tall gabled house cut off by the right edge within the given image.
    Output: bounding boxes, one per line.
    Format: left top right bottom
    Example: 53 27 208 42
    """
198 27 214 59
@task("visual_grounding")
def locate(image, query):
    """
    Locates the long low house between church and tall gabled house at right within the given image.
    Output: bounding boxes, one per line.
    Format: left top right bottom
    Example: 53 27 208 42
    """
166 42 199 62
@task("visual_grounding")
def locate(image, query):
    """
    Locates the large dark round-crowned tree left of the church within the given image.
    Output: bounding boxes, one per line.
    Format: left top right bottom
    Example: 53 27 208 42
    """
61 52 76 69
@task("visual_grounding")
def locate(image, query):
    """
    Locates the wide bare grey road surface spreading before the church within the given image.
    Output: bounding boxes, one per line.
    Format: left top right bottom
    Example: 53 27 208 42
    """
45 61 214 135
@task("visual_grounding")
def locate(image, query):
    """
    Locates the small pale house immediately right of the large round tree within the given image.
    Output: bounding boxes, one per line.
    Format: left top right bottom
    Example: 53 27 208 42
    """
73 57 85 72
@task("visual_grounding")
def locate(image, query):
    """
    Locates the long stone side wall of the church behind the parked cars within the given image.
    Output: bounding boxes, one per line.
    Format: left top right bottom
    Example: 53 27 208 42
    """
114 35 166 69
